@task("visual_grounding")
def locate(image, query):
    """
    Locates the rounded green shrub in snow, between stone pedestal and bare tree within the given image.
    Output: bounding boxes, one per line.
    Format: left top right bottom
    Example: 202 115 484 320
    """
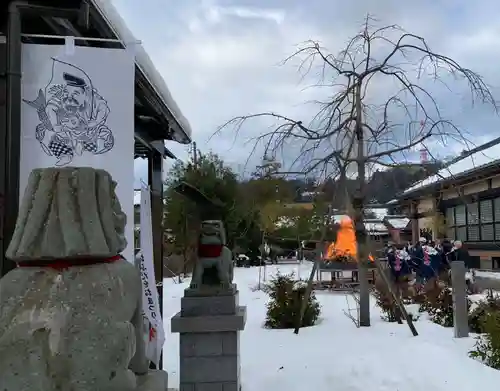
263 274 321 329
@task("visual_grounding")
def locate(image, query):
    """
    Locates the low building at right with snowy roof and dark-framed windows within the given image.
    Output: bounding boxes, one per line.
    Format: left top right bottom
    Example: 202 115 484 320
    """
397 138 500 268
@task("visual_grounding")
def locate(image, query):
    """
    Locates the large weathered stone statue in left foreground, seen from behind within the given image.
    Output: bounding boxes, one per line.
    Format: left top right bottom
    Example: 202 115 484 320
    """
0 167 167 391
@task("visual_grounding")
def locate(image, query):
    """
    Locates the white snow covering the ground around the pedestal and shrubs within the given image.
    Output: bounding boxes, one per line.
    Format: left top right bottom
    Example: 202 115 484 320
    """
164 265 500 391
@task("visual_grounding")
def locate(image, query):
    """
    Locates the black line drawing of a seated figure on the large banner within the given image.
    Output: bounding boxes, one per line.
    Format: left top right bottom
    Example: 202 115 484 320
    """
23 58 115 166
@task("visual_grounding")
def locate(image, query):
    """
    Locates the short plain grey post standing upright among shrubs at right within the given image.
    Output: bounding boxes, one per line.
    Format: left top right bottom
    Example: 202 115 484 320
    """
451 261 469 338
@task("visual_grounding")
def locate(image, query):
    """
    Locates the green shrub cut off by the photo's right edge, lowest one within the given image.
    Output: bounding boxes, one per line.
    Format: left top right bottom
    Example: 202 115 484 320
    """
469 311 500 369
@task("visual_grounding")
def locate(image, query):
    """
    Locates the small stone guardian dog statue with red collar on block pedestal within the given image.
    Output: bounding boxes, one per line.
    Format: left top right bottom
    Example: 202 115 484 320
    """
190 220 233 289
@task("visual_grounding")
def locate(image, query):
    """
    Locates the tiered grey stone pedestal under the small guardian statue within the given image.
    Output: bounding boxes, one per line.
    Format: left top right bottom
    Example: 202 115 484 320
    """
171 284 246 391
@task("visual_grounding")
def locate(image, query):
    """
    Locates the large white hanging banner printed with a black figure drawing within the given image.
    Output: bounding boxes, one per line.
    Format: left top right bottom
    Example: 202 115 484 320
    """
19 44 135 263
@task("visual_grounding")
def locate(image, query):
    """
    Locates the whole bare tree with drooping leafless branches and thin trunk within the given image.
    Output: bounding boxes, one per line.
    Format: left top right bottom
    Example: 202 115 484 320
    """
219 16 497 326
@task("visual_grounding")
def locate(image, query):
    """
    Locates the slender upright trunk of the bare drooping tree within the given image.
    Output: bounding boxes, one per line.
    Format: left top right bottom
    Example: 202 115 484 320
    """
353 81 370 327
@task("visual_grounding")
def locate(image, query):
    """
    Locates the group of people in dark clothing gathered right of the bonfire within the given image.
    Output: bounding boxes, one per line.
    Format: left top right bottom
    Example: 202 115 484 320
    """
385 238 469 292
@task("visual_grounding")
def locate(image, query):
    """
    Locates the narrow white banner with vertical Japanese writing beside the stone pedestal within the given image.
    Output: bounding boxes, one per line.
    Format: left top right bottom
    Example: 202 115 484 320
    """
140 187 165 368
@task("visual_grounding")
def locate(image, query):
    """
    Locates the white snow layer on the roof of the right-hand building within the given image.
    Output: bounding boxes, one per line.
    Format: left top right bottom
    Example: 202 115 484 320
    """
402 139 500 196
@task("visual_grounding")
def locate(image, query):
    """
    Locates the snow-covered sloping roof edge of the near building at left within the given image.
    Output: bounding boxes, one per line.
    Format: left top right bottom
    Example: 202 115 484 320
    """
92 0 192 142
